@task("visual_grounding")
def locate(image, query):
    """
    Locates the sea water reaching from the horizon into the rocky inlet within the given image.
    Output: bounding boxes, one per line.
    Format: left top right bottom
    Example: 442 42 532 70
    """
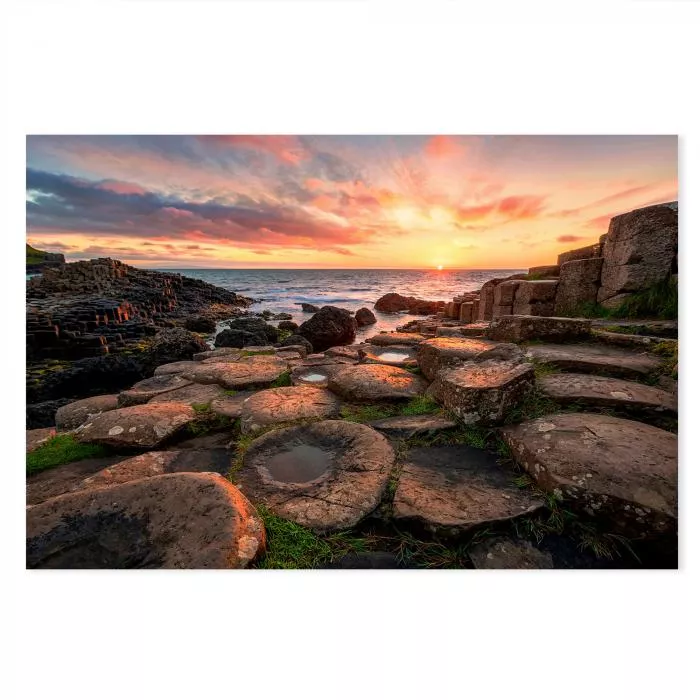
163 269 526 338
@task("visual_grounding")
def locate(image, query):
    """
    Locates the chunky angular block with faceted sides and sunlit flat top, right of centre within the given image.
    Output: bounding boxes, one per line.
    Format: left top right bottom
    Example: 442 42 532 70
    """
428 359 535 425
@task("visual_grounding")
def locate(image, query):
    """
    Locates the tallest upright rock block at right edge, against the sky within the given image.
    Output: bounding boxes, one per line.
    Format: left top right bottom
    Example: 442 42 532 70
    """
598 202 678 303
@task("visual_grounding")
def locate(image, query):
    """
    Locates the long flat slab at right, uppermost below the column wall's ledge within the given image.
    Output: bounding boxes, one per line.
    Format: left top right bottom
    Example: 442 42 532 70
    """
526 344 661 379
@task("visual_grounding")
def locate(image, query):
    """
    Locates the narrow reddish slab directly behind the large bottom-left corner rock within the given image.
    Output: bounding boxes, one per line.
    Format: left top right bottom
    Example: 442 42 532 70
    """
76 449 231 491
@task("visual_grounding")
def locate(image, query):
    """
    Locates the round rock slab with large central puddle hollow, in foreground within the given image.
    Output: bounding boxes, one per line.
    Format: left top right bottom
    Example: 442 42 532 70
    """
235 420 394 533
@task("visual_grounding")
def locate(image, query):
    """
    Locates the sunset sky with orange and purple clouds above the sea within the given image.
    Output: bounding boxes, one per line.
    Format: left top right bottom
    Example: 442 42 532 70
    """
27 135 678 269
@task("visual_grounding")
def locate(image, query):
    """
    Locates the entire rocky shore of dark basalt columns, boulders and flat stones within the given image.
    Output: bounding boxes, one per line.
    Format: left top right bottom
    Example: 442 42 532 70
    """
27 203 678 568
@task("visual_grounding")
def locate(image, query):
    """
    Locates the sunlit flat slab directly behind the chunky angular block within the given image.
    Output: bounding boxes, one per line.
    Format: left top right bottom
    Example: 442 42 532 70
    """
418 337 523 381
